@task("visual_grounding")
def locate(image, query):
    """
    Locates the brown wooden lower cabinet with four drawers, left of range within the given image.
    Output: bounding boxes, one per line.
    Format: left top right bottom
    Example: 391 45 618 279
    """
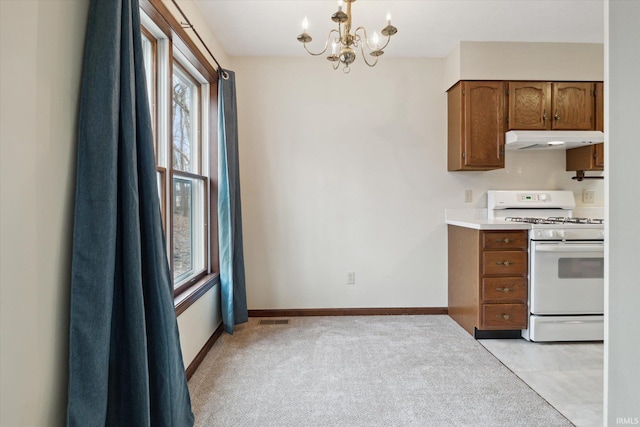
448 225 528 337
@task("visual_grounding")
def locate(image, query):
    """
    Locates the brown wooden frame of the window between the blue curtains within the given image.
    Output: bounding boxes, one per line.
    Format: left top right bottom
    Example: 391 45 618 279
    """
140 0 219 308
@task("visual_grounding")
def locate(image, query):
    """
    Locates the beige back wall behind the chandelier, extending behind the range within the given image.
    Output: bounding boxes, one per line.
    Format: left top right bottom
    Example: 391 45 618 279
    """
235 57 603 309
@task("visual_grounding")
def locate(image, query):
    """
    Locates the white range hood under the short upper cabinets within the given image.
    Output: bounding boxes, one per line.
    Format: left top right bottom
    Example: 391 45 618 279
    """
505 130 604 150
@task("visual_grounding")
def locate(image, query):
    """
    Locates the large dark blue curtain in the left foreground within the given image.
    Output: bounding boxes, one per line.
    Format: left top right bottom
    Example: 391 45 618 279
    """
67 0 194 427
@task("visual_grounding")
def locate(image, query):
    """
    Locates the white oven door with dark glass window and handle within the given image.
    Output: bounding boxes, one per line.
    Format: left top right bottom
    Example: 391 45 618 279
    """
529 241 604 315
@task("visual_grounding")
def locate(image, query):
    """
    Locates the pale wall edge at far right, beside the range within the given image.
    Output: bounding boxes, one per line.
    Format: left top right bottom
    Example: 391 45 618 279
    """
604 1 640 426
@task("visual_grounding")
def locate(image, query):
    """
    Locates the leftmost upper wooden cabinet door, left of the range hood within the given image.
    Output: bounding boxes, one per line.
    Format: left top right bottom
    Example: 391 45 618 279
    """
463 81 505 169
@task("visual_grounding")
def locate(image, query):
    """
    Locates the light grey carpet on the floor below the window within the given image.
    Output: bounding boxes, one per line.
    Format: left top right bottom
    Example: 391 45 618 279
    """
189 316 572 427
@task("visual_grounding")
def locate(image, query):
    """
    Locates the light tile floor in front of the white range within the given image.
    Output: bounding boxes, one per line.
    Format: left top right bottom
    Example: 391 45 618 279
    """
478 339 604 427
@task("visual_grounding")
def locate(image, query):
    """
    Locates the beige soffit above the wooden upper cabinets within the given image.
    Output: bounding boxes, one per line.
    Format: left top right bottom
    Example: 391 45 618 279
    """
444 41 604 89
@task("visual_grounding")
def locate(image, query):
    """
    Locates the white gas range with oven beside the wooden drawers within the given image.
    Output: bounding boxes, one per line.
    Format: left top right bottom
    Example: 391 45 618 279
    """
487 190 604 342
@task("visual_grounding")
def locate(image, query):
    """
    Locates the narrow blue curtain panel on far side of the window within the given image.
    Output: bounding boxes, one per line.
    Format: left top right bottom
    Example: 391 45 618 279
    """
218 69 248 334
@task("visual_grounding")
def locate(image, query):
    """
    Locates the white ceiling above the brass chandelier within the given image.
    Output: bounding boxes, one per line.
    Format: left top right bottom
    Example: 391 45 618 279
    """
195 0 604 57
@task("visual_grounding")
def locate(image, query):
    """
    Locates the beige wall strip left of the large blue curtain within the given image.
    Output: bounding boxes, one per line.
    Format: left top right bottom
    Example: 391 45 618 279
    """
0 0 89 427
